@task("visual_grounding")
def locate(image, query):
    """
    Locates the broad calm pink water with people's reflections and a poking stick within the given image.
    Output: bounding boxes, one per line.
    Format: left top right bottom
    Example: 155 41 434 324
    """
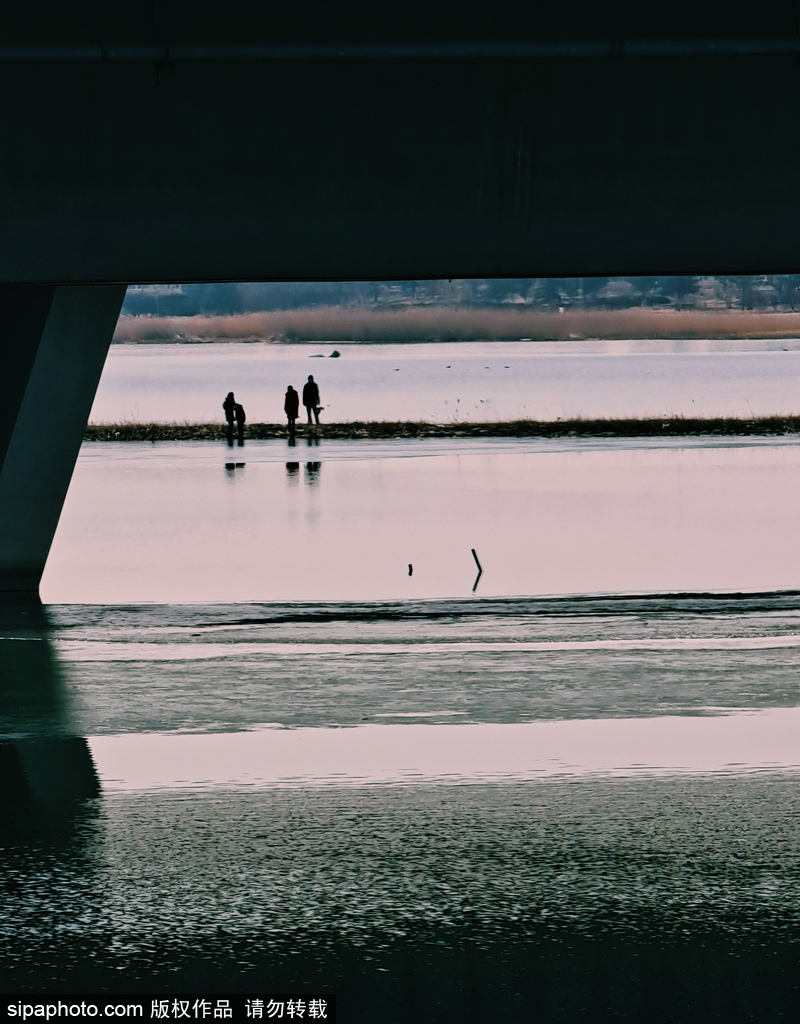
42 438 800 603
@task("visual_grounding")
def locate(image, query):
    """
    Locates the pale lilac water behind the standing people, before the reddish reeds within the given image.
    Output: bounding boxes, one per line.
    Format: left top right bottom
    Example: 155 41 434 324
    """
91 340 800 423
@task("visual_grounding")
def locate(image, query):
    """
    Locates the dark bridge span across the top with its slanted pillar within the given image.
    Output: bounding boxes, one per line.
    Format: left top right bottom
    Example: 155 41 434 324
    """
0 0 800 591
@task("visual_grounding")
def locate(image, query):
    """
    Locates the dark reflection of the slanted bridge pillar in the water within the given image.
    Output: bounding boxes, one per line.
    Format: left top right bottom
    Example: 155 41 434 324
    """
0 597 102 991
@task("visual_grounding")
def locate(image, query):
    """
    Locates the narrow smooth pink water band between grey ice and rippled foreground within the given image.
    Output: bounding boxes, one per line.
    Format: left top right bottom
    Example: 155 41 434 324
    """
91 708 800 793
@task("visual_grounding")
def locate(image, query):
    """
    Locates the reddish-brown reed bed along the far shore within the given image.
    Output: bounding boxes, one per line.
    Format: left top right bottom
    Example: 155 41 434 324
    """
114 306 800 344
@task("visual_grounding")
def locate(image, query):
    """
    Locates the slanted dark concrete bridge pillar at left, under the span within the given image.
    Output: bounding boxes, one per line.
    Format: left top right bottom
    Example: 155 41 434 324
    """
0 285 125 592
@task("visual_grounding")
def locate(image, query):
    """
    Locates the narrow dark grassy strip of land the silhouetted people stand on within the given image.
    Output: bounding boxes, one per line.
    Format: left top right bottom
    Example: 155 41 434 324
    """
84 415 800 441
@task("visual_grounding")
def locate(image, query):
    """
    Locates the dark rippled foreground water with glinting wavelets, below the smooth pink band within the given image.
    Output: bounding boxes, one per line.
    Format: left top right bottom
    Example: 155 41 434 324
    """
0 777 800 954
